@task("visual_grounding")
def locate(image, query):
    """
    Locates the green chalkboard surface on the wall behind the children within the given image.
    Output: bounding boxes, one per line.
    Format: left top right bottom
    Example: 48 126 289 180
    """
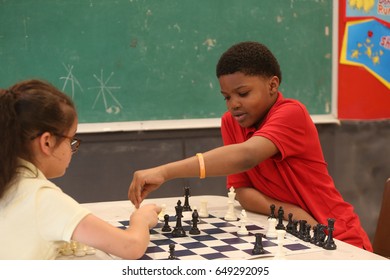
0 0 333 123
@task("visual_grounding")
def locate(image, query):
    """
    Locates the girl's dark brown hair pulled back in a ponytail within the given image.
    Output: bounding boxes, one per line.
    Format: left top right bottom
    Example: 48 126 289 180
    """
0 80 77 198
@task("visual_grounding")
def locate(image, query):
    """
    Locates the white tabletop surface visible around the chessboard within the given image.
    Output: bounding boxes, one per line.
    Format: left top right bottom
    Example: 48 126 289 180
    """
58 196 387 260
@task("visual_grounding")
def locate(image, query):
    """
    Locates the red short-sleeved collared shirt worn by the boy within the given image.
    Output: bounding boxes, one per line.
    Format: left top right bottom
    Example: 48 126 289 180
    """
221 93 372 251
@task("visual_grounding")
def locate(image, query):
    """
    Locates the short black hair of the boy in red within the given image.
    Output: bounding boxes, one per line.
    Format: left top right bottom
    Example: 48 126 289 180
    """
216 42 282 83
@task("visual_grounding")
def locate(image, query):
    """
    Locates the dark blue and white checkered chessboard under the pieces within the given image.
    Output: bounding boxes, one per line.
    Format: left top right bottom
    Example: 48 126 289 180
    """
115 211 325 260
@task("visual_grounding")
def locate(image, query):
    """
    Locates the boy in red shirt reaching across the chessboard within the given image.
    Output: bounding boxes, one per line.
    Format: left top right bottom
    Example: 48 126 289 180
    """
129 42 372 251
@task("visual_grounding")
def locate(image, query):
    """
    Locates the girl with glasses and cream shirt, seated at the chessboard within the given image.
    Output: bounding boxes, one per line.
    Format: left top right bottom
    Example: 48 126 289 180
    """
0 80 160 259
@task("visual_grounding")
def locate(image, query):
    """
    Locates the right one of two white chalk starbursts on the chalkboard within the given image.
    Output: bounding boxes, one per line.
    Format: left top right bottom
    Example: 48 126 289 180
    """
88 69 123 114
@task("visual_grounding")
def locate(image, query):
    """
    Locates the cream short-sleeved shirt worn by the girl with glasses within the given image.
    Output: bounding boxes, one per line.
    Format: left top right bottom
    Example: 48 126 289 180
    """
0 160 90 260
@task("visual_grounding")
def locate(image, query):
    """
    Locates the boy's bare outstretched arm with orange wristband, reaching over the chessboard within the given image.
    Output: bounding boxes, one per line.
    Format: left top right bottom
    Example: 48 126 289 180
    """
128 136 278 208
